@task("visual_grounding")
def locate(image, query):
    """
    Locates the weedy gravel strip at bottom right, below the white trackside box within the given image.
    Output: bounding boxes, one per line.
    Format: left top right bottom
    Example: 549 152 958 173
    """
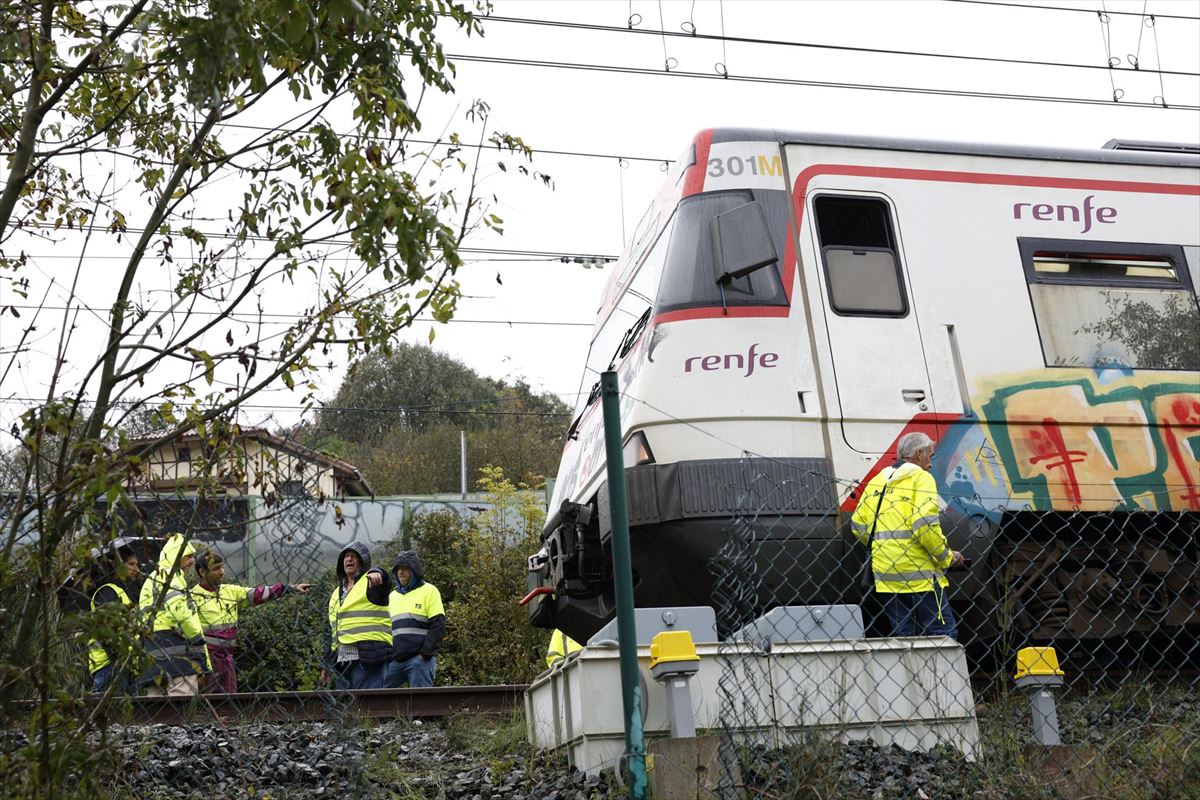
737 684 1200 800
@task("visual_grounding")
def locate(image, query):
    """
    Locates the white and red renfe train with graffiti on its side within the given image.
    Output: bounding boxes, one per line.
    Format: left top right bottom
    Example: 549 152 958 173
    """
528 130 1200 657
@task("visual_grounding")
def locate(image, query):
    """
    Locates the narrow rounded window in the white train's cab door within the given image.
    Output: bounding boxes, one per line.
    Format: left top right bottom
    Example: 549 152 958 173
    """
812 197 908 317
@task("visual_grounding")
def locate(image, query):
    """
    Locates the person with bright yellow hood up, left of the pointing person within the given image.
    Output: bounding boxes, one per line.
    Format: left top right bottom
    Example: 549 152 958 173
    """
138 534 210 696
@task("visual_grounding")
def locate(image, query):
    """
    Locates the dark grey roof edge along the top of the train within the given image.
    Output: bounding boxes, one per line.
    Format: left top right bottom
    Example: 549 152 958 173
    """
712 128 1200 167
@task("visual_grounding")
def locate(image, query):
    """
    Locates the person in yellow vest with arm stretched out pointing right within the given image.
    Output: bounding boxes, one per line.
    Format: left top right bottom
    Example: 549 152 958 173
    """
192 551 312 692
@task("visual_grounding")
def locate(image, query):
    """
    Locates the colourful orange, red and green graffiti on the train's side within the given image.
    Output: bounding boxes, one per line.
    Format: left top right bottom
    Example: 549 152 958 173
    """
934 369 1200 513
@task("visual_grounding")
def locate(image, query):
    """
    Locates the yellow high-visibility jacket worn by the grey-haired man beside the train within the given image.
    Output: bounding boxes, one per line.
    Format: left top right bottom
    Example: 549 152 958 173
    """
850 463 954 594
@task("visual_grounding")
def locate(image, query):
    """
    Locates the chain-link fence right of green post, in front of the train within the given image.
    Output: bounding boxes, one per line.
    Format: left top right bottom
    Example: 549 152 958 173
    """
710 457 1200 798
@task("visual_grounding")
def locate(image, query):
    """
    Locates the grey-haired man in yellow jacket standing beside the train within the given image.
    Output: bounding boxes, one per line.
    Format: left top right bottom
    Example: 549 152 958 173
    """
851 433 964 639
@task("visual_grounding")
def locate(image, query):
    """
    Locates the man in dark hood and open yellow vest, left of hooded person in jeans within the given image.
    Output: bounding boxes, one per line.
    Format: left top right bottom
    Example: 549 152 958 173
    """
322 542 391 688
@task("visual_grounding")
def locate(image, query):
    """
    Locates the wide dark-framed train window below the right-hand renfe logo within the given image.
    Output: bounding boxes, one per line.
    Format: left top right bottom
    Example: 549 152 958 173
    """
1018 237 1200 371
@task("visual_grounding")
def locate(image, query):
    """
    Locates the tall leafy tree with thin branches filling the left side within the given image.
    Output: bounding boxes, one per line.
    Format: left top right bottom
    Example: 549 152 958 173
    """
0 0 551 798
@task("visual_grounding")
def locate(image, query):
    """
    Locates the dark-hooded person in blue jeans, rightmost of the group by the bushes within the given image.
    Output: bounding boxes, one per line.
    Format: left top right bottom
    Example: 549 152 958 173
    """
385 551 446 688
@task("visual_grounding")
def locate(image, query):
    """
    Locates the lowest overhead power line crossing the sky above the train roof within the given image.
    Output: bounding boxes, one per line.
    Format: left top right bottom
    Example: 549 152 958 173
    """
446 54 1200 112
